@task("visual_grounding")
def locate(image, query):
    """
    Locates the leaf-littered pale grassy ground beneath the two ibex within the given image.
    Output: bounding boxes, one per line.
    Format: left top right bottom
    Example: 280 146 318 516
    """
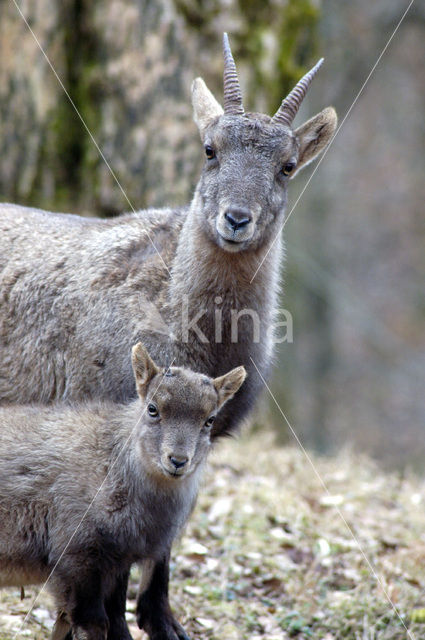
0 433 425 640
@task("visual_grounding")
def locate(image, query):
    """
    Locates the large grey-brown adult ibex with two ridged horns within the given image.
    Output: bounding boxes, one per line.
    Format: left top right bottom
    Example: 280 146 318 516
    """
0 35 336 640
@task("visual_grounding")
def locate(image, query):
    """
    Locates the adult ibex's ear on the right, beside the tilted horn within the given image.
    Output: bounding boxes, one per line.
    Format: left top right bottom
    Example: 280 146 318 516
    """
291 107 338 178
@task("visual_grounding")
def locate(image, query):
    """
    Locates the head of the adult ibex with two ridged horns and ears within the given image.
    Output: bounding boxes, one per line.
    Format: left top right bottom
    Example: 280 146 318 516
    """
192 34 337 252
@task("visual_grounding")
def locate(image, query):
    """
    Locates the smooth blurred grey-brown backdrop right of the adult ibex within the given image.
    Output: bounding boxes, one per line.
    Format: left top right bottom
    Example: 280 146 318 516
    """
274 0 425 468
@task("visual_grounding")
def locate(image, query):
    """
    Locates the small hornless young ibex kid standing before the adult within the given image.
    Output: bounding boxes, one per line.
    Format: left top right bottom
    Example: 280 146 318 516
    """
0 343 246 640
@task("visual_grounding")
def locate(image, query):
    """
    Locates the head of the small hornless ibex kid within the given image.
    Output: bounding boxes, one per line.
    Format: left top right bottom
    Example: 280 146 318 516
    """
132 342 246 479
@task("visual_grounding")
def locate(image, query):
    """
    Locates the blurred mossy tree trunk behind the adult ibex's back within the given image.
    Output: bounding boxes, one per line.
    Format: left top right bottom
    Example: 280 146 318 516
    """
0 0 319 215
